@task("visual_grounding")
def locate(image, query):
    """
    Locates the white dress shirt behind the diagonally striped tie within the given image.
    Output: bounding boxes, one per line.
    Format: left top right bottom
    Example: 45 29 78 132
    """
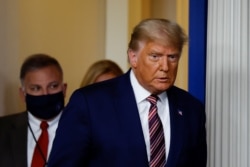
130 70 170 160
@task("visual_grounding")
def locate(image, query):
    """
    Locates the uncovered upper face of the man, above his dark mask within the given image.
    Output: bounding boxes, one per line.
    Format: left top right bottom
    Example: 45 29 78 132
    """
20 66 67 99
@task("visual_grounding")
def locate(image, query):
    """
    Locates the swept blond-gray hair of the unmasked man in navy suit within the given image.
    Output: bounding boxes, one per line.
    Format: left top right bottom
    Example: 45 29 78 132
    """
128 18 187 51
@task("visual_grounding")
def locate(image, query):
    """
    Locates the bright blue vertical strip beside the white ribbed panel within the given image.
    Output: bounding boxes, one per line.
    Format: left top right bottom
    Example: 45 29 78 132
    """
188 0 207 104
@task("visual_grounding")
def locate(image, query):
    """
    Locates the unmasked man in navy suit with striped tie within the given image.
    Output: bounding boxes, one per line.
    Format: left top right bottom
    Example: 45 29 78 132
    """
48 19 207 167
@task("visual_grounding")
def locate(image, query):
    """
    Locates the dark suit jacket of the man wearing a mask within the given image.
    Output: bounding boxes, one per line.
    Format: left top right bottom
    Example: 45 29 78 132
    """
0 112 28 167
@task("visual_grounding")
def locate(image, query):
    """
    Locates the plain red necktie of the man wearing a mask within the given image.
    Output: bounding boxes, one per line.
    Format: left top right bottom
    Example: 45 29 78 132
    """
31 121 49 167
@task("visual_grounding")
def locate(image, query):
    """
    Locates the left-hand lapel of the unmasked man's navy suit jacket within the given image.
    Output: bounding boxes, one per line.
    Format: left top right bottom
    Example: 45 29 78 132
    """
115 72 148 166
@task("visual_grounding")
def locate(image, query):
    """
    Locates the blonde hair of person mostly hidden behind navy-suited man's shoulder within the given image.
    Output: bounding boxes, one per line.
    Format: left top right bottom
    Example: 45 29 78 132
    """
80 60 123 87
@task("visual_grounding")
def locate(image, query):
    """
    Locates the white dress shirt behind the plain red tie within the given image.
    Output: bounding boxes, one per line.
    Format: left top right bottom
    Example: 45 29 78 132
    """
27 112 62 166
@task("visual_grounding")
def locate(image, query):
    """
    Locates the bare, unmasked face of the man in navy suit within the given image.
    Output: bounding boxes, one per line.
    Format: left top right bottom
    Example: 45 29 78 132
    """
128 42 180 94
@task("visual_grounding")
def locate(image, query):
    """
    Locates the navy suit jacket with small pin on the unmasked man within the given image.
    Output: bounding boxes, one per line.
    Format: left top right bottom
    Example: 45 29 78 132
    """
48 72 207 167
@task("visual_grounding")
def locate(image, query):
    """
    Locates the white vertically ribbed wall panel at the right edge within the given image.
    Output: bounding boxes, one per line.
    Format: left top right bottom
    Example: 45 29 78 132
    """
206 0 250 167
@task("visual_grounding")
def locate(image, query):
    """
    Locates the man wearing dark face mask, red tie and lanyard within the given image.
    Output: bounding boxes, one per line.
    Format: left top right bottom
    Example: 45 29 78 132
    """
0 54 67 167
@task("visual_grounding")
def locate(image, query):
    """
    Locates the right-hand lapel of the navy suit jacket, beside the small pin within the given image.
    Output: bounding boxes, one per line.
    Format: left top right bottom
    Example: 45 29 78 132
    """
167 87 185 167
